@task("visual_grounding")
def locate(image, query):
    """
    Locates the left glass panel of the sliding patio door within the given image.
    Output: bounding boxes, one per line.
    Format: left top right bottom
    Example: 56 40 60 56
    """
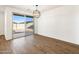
13 15 26 39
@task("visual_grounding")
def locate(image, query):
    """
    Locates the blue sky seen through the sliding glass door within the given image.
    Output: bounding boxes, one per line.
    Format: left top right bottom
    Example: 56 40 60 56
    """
13 15 32 23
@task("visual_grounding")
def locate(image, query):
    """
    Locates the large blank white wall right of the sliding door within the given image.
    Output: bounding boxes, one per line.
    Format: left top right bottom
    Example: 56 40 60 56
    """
37 6 79 44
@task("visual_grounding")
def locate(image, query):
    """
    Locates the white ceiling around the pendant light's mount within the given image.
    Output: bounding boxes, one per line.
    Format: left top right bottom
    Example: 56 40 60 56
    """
6 5 59 12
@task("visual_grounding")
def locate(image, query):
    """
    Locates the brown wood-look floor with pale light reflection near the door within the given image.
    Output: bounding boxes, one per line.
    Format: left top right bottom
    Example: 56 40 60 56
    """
0 35 79 54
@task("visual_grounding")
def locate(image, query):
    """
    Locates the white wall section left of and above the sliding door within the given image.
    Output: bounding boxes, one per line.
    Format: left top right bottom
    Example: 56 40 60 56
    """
5 7 32 40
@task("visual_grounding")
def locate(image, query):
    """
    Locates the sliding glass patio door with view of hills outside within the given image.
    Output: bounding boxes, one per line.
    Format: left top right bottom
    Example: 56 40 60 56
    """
12 14 34 39
